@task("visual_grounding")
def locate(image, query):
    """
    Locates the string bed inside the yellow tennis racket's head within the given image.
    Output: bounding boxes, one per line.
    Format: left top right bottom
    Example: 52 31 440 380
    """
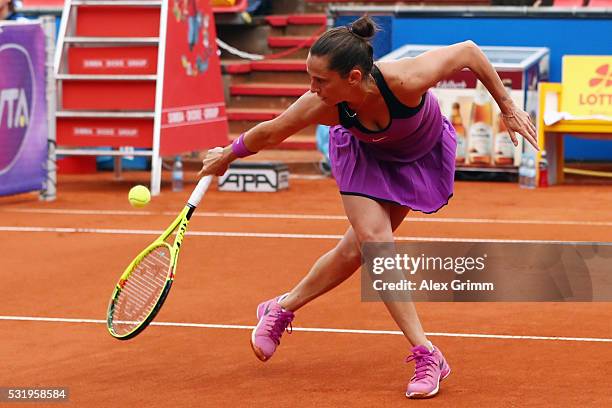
113 246 170 336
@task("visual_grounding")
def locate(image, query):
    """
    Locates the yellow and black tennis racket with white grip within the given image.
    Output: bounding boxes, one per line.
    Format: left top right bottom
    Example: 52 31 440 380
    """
106 176 212 340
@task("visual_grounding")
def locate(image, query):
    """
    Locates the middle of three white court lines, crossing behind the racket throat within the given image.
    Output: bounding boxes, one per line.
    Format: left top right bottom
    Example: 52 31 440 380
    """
0 226 607 245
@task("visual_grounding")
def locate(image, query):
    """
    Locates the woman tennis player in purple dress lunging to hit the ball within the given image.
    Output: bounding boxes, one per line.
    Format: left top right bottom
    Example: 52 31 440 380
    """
201 16 537 398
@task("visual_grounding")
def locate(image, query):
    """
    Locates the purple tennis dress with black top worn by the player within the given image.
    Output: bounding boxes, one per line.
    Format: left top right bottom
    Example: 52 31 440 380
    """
329 66 457 213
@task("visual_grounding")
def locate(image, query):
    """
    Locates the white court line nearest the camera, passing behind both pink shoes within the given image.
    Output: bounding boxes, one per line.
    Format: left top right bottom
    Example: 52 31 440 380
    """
0 316 612 343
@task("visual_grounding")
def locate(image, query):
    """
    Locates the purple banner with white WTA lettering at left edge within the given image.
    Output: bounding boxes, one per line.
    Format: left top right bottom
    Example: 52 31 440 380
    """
0 24 48 195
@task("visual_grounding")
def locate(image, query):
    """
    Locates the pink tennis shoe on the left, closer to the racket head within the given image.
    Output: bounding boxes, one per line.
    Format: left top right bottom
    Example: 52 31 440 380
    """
251 293 294 361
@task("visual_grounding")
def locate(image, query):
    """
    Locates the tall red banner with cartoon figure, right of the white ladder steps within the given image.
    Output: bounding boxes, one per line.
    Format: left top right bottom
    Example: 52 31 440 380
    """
160 0 228 155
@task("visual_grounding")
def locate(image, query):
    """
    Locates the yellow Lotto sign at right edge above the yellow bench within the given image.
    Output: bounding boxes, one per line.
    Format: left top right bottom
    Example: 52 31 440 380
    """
561 55 612 118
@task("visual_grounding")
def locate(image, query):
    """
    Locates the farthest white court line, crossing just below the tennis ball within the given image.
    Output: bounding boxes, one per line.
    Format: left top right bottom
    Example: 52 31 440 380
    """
0 208 612 227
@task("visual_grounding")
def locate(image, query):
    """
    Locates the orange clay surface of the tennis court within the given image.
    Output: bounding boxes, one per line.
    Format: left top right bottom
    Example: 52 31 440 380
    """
0 172 612 408
